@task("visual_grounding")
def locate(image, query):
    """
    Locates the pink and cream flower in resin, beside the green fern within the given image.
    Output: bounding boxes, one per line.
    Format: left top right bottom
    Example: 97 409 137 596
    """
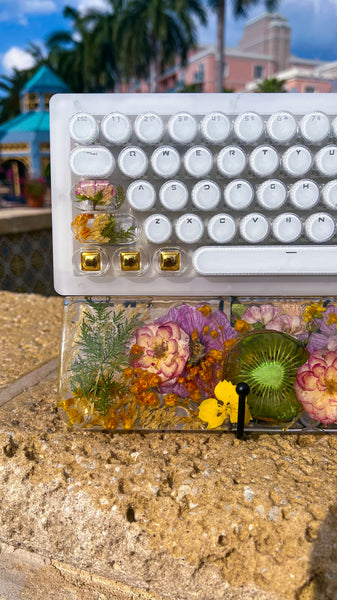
131 321 190 383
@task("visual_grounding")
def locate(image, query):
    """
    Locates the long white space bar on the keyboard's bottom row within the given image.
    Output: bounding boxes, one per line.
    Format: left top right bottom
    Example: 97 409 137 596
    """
193 246 337 275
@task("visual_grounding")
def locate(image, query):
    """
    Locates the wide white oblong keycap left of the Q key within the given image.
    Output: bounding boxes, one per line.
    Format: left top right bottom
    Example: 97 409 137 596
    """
69 146 115 177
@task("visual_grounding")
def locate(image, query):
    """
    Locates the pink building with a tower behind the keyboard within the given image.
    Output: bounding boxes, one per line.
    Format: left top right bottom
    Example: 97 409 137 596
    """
123 13 337 93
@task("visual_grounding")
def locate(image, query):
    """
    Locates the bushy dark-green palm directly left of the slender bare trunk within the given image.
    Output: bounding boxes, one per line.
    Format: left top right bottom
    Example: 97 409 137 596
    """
119 0 206 92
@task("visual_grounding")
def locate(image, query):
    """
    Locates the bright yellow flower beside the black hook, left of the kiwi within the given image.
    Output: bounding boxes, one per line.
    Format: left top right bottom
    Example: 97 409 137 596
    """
199 380 252 429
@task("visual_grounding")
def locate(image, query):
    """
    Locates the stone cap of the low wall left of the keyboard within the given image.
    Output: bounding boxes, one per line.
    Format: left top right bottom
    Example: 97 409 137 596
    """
0 207 51 235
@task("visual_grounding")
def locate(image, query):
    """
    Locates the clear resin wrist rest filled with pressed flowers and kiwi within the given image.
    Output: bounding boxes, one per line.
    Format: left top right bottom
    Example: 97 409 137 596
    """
58 297 337 432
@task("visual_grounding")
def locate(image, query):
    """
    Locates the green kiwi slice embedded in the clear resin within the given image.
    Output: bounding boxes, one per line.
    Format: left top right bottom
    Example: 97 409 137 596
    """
223 329 309 422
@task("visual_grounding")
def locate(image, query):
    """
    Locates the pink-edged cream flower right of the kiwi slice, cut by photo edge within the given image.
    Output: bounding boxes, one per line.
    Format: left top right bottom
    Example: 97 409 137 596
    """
295 350 337 425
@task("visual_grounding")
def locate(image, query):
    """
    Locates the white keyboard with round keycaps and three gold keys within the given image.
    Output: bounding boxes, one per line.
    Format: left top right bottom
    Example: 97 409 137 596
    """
50 94 337 297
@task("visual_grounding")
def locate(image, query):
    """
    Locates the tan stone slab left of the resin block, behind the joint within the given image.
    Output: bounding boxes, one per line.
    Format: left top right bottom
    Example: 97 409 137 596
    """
0 292 63 388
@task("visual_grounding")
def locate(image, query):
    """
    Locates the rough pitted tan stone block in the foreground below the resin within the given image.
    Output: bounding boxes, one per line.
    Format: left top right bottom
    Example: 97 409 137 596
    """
0 292 337 600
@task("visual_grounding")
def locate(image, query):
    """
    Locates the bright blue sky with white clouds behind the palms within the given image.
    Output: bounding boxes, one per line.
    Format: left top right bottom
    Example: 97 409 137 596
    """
0 0 337 75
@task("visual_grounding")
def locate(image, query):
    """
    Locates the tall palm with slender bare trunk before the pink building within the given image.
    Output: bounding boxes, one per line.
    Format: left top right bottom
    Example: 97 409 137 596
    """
207 0 279 92
